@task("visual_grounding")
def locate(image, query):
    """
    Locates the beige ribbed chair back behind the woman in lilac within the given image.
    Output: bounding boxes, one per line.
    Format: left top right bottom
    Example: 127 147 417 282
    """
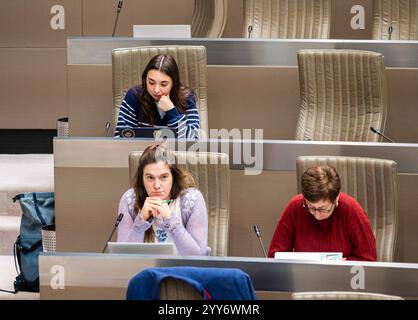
129 151 230 256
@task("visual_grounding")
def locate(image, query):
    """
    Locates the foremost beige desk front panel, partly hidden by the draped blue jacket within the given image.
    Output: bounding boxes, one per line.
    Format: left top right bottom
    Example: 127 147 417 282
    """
39 253 418 300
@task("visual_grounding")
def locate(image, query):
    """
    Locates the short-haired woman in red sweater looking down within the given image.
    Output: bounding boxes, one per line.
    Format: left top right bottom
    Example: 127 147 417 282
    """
268 165 376 261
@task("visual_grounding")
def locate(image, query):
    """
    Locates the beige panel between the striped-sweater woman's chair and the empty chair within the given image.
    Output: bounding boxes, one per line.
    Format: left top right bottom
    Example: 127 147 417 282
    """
208 66 299 140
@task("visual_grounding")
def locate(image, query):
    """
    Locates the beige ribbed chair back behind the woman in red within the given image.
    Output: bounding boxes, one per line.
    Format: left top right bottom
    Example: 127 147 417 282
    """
296 156 398 261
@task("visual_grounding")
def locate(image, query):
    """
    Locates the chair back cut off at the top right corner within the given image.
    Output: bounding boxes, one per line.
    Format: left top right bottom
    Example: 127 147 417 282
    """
372 0 418 40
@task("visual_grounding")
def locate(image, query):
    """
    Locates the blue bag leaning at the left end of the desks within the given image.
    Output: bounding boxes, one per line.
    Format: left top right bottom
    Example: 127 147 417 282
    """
13 192 55 292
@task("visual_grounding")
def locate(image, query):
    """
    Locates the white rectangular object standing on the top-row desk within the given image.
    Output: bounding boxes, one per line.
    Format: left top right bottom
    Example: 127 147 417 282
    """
133 24 192 38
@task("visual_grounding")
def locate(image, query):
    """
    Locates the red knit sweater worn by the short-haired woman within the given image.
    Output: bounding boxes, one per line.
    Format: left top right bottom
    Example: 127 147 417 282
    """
268 193 376 261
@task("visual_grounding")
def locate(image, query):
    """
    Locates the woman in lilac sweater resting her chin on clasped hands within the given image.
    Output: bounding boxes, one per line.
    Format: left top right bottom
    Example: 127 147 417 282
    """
118 145 210 255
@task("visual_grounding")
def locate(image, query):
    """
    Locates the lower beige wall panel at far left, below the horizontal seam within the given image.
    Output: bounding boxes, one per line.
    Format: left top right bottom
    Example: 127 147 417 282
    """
0 48 68 129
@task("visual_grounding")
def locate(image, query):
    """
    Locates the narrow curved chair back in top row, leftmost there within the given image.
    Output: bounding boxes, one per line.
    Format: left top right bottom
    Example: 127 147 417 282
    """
192 0 228 38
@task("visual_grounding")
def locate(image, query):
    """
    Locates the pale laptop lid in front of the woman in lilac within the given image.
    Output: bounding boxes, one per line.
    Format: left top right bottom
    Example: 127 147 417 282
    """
107 242 175 254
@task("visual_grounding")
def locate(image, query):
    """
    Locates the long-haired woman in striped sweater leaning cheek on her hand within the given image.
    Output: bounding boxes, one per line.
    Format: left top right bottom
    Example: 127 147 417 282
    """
115 54 199 139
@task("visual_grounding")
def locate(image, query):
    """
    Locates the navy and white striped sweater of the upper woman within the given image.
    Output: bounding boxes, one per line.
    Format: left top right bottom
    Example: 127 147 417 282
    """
115 86 199 139
